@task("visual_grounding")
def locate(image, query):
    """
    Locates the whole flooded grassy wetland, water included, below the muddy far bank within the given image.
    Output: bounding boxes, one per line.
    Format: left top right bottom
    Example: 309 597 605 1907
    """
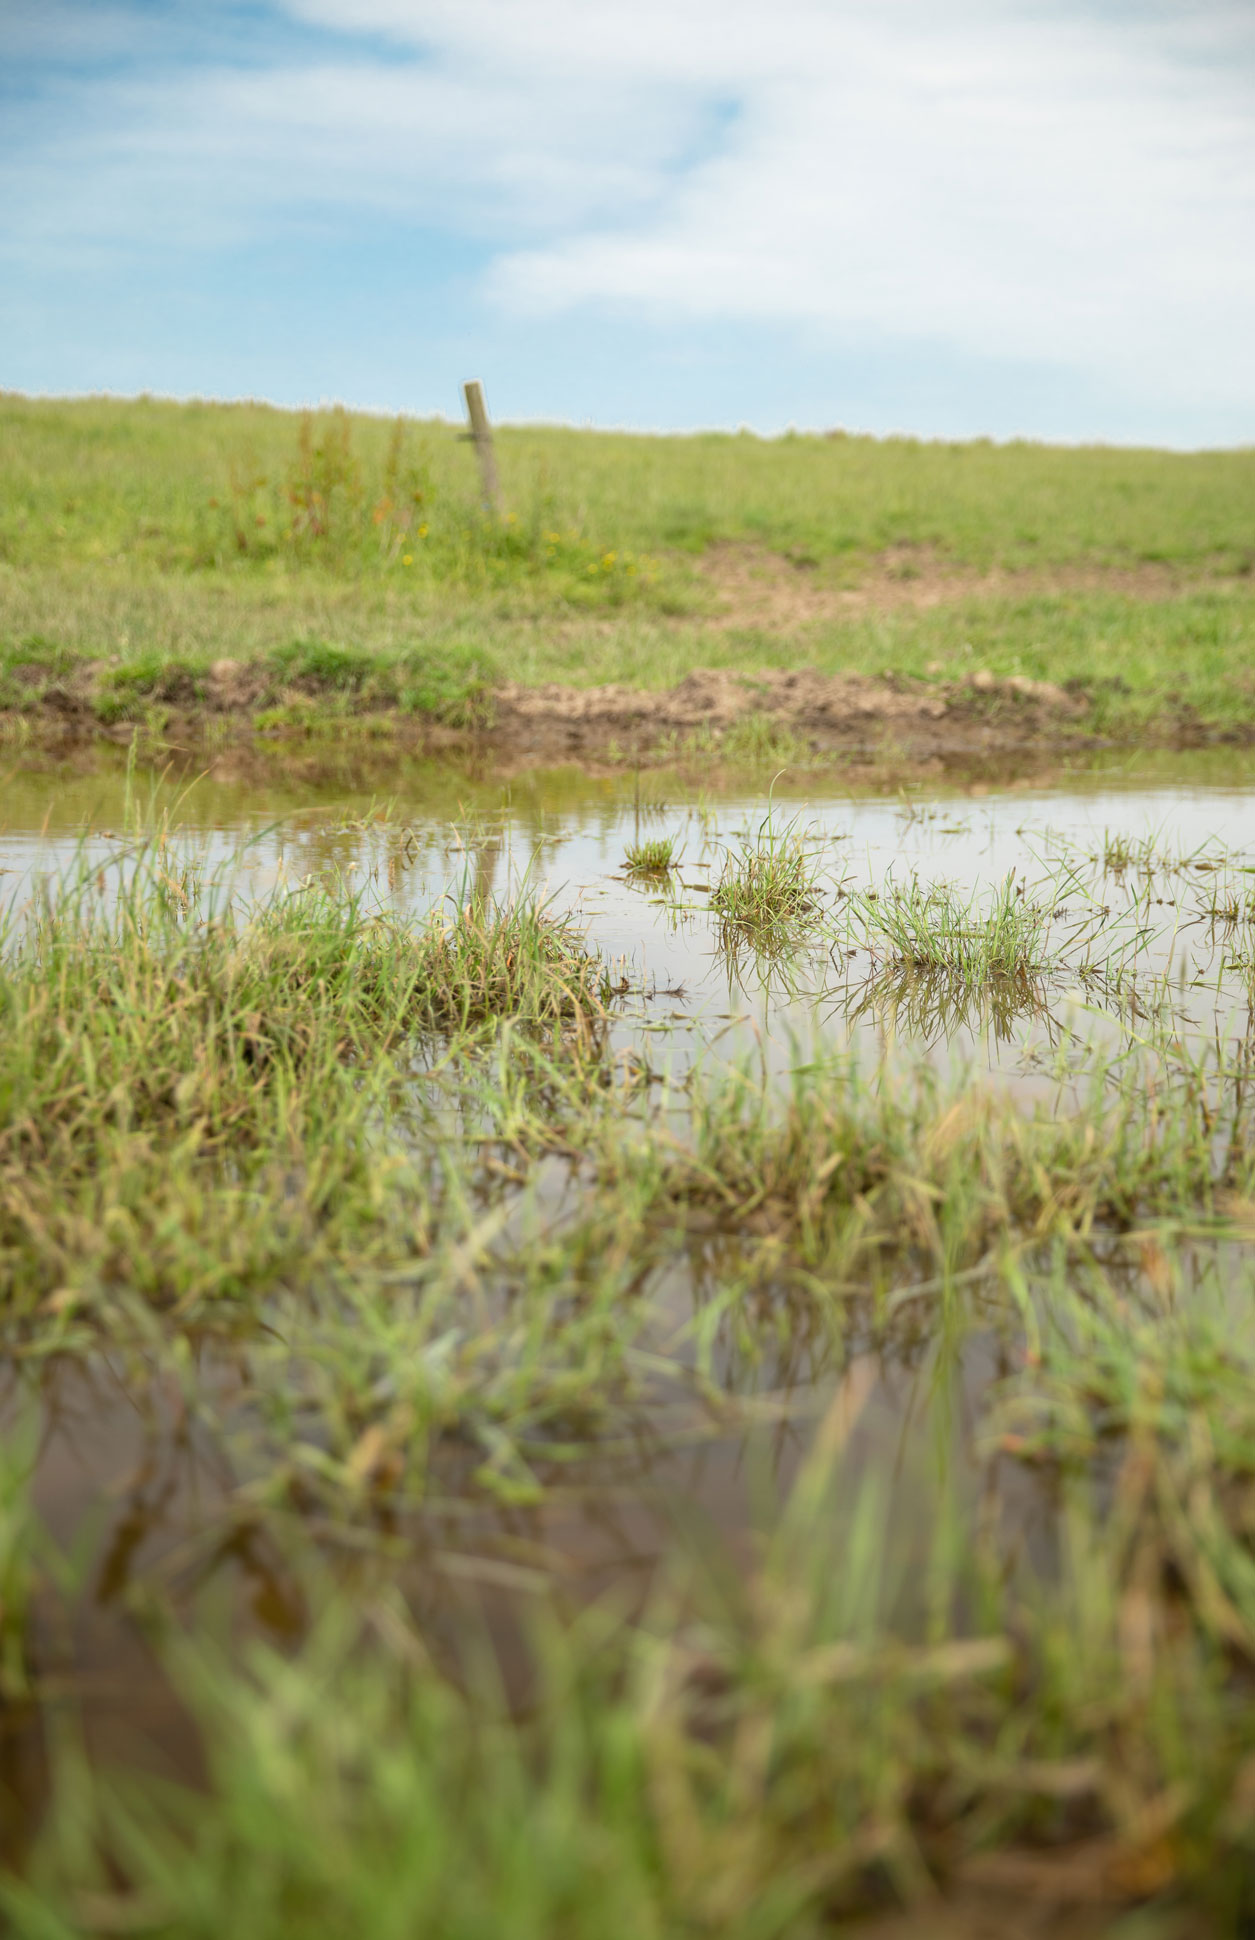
0 741 1255 1940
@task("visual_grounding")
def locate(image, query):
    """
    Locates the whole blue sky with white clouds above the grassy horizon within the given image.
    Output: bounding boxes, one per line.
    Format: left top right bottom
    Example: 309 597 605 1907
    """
0 0 1255 446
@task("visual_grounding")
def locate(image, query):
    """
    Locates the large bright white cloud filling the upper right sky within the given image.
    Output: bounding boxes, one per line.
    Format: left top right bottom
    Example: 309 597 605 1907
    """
279 0 1255 402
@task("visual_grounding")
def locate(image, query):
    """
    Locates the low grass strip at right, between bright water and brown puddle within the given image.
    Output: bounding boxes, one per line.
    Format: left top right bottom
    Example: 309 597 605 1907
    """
628 1057 1255 1295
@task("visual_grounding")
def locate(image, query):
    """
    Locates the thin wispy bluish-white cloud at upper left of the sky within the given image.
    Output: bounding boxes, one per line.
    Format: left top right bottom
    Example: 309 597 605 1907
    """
0 21 702 252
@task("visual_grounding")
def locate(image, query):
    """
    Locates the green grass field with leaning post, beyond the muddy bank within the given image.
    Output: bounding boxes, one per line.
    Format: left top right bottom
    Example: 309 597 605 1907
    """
0 396 1255 735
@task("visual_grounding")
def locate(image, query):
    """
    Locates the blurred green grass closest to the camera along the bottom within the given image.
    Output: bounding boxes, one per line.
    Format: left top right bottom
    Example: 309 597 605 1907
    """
17 1370 1255 1940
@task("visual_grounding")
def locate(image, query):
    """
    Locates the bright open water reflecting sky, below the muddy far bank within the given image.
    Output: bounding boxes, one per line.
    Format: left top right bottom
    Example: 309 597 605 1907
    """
0 751 1255 1090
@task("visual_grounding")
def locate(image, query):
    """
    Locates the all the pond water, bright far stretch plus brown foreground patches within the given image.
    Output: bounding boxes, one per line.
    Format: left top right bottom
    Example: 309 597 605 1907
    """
0 737 1255 1846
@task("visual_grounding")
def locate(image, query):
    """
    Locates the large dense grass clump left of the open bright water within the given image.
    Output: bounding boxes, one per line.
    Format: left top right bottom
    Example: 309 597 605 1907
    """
0 842 605 1315
